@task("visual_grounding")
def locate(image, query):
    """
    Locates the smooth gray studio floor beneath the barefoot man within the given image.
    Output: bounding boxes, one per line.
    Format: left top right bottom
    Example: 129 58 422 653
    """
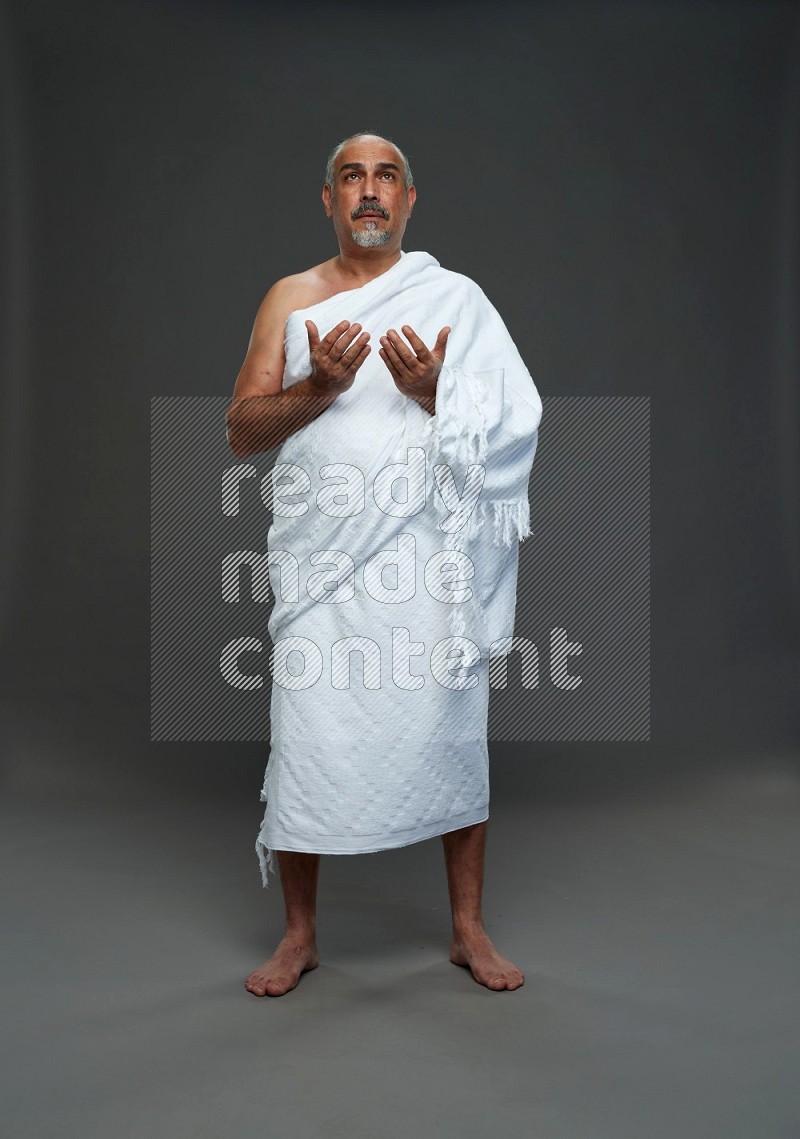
2 697 800 1139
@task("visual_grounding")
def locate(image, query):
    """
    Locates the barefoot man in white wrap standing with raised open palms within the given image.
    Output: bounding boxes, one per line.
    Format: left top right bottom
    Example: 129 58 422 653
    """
227 133 541 997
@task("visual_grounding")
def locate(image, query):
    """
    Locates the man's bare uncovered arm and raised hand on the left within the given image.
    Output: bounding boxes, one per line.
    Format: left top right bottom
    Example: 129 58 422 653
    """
226 281 369 459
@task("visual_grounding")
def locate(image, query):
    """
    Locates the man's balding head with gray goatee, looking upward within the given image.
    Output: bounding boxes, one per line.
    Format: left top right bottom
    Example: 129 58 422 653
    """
323 136 417 252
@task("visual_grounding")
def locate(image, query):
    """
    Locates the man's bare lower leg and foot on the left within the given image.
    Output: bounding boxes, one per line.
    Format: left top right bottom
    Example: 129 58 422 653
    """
245 851 319 997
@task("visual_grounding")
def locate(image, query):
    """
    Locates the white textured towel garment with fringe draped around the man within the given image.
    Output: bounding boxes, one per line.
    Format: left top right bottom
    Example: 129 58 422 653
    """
255 252 541 886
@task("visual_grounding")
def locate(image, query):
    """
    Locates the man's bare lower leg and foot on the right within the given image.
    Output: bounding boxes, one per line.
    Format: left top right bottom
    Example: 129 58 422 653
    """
442 822 525 990
